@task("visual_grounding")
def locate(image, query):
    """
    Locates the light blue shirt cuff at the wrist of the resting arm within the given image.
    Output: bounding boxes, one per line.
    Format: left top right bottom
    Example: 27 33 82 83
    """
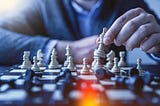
43 40 58 64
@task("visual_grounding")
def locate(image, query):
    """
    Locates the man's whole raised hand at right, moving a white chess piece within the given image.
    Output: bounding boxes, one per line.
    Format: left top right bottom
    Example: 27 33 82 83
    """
104 8 160 53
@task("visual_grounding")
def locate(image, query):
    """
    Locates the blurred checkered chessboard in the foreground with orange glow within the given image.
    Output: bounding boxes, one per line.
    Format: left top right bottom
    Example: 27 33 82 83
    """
0 65 160 106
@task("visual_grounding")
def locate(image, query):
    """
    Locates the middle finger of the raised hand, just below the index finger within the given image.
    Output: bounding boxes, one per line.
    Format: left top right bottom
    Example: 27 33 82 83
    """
115 13 152 46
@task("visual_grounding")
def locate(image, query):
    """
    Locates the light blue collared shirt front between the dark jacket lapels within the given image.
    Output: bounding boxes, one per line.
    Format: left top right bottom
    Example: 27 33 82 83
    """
72 0 103 37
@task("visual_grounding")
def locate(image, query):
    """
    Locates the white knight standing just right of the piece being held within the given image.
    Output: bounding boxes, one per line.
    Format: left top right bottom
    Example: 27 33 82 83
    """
106 50 115 70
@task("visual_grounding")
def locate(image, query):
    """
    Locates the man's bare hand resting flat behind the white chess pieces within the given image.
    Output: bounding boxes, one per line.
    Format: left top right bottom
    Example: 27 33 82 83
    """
56 35 98 64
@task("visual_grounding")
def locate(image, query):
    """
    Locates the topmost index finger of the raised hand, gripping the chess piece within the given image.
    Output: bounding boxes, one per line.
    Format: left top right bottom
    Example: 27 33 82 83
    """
104 8 145 45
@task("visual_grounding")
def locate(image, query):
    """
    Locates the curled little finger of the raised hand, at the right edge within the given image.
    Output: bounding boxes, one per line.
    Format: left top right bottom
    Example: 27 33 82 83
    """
140 33 160 53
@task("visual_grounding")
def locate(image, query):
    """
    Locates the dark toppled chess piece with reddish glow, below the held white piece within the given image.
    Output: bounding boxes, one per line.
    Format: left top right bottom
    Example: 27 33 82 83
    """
95 68 115 80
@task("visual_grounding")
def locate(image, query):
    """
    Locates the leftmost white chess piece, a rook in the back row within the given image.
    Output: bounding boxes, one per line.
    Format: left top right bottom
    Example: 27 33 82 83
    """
20 51 32 69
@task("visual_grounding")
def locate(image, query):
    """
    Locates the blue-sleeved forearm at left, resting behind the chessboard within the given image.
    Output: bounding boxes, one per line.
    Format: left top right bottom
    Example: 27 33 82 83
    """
0 28 49 65
